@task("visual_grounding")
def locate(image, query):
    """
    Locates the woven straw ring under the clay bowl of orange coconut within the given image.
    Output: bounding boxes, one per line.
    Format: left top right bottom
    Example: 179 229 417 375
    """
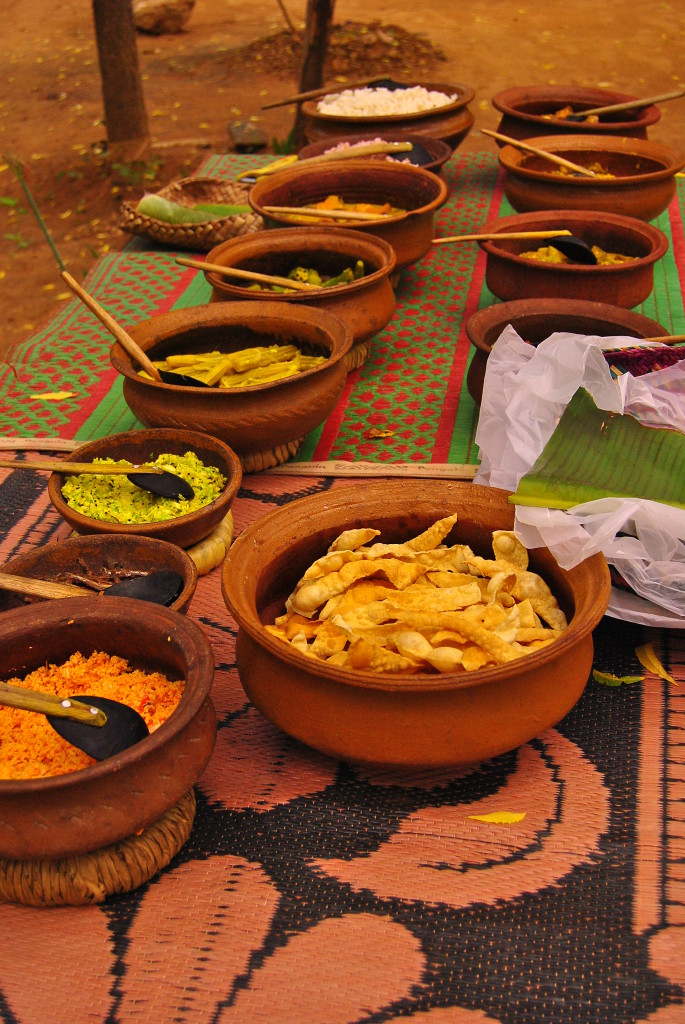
0 790 196 906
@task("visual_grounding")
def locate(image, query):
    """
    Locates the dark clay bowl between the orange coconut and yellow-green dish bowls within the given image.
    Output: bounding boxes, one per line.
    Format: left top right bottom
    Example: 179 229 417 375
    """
0 534 198 612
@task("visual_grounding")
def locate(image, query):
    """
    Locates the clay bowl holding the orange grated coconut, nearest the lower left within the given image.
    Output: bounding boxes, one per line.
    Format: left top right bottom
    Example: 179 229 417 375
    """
0 597 216 860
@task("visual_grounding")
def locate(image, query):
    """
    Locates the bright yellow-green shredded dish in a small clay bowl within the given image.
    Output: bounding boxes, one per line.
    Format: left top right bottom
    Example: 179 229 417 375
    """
61 452 226 524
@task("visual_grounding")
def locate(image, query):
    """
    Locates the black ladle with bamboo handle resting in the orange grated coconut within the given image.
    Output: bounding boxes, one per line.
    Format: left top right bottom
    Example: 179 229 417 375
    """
0 683 149 761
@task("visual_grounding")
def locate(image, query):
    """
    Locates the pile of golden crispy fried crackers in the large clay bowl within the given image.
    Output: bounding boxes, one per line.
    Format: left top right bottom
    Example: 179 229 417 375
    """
266 513 567 674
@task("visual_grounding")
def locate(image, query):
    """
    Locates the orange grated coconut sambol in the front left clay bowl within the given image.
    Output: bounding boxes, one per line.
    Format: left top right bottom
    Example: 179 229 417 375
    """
0 651 185 779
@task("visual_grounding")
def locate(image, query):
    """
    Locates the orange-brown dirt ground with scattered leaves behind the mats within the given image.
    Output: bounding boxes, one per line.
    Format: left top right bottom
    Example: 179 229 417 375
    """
0 0 685 355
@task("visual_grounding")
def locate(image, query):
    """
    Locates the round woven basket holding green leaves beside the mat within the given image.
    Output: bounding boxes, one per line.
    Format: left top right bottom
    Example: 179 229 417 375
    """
119 178 263 252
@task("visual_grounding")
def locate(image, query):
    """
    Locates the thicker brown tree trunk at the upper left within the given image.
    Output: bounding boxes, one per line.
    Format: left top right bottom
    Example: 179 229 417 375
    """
92 0 149 157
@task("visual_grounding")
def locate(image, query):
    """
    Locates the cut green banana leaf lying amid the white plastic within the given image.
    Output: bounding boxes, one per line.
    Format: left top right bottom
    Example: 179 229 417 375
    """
509 388 685 509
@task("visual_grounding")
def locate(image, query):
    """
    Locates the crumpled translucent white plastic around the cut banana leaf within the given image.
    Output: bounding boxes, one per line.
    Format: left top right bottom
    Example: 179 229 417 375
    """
474 326 685 625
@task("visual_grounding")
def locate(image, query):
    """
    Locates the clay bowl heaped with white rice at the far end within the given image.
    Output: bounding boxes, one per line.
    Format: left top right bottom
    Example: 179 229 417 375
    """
300 81 475 153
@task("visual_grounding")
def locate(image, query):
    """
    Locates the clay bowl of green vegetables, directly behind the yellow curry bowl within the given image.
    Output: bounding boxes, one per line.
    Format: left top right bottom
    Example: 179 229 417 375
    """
205 227 395 370
